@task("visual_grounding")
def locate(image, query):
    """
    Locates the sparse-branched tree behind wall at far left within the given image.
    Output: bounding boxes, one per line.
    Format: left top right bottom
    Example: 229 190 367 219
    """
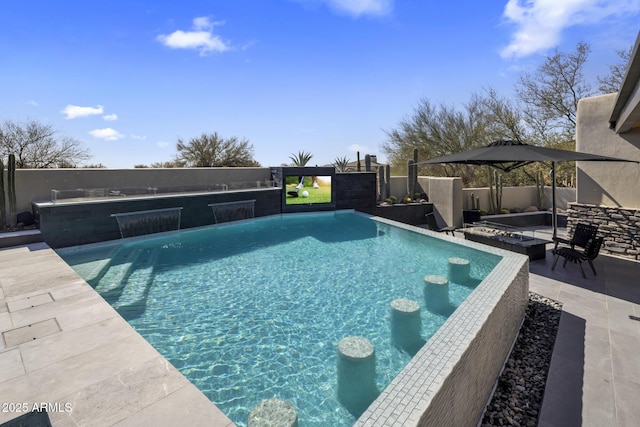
0 120 91 169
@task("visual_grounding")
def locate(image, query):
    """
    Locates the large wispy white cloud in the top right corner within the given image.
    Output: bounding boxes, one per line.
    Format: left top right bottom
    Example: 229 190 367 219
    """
500 0 640 58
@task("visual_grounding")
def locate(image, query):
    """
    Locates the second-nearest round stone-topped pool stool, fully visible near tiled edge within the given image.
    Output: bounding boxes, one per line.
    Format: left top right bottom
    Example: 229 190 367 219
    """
338 336 378 418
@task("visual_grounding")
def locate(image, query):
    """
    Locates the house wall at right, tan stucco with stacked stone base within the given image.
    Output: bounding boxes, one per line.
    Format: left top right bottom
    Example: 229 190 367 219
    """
568 33 640 261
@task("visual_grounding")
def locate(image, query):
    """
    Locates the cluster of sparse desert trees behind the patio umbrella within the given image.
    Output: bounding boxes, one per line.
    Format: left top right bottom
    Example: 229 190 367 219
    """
383 43 631 186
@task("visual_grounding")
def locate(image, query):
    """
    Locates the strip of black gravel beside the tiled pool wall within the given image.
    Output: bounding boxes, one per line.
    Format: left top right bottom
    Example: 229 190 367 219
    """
481 292 562 427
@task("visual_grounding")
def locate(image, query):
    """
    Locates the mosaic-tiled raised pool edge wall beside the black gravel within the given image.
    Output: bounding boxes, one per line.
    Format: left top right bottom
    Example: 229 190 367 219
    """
355 220 529 427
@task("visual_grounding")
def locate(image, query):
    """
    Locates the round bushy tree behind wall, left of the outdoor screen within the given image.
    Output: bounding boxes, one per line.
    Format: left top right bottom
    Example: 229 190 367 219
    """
175 132 260 167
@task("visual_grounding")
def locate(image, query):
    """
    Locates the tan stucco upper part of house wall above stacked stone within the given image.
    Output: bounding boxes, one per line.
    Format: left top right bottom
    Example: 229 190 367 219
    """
576 93 640 208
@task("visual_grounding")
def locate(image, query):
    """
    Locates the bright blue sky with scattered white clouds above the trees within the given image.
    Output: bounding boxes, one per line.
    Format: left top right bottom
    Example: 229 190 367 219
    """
0 0 640 168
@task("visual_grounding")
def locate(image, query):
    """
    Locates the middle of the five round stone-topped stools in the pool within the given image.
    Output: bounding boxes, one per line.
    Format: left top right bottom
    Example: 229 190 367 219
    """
391 298 425 356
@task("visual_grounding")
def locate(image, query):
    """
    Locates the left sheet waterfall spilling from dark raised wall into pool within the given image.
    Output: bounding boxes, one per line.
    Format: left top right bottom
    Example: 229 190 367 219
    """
111 207 182 238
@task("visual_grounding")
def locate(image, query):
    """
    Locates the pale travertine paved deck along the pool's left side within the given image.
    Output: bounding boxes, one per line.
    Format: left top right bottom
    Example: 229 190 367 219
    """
0 243 234 427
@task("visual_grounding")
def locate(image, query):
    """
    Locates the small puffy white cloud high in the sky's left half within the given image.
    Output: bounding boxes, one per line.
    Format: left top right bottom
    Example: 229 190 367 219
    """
156 16 231 56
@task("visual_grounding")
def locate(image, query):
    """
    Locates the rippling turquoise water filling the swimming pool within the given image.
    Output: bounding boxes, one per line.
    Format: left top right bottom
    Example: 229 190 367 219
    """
59 212 500 427
